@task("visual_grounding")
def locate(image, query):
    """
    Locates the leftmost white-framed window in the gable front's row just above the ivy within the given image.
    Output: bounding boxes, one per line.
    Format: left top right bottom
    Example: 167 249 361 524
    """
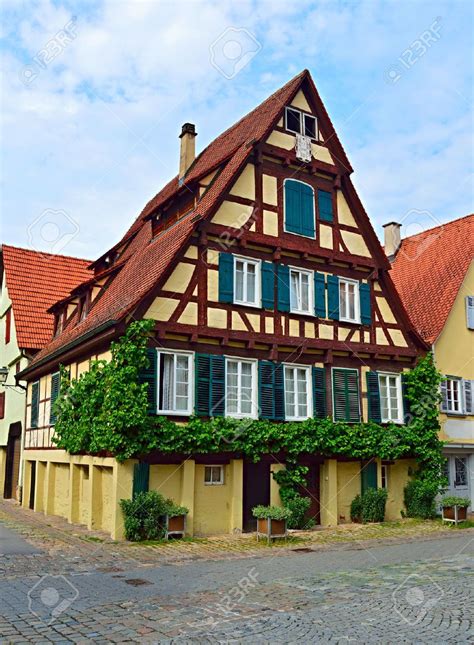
157 350 193 416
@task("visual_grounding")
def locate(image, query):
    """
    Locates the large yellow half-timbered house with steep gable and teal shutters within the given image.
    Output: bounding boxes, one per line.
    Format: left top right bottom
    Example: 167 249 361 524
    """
18 71 426 537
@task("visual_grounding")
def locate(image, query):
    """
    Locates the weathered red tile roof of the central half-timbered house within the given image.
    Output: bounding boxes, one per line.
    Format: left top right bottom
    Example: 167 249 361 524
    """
23 70 356 368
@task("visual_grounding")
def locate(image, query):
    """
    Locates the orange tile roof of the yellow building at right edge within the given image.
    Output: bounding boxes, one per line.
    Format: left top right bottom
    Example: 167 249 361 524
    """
390 215 474 343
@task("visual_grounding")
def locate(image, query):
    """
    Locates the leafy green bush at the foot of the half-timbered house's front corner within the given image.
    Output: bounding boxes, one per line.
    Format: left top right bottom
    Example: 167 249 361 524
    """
120 490 170 542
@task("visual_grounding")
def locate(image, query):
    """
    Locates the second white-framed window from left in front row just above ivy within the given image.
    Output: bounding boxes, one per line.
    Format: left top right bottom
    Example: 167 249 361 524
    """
225 358 258 419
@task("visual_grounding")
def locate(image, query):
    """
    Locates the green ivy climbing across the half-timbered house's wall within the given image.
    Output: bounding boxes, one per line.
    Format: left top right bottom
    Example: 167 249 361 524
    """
55 320 444 489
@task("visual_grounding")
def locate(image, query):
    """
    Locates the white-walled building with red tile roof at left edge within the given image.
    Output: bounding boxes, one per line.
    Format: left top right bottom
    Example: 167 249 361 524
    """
0 244 92 497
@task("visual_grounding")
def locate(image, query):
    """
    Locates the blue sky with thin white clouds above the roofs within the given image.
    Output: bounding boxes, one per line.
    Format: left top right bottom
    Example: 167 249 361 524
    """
1 0 473 259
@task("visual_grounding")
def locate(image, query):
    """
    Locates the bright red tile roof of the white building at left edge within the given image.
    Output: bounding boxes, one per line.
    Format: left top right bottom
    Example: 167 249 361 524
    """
2 244 91 349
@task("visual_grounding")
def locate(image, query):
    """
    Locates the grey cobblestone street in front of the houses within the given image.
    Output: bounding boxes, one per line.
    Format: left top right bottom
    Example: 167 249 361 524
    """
0 504 474 643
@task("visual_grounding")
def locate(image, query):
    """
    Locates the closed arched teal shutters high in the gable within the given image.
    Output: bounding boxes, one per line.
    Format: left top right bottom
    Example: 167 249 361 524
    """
284 179 315 237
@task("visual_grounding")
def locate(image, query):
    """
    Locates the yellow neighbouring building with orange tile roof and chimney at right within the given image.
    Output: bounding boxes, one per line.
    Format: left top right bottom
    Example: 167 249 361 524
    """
385 215 474 508
